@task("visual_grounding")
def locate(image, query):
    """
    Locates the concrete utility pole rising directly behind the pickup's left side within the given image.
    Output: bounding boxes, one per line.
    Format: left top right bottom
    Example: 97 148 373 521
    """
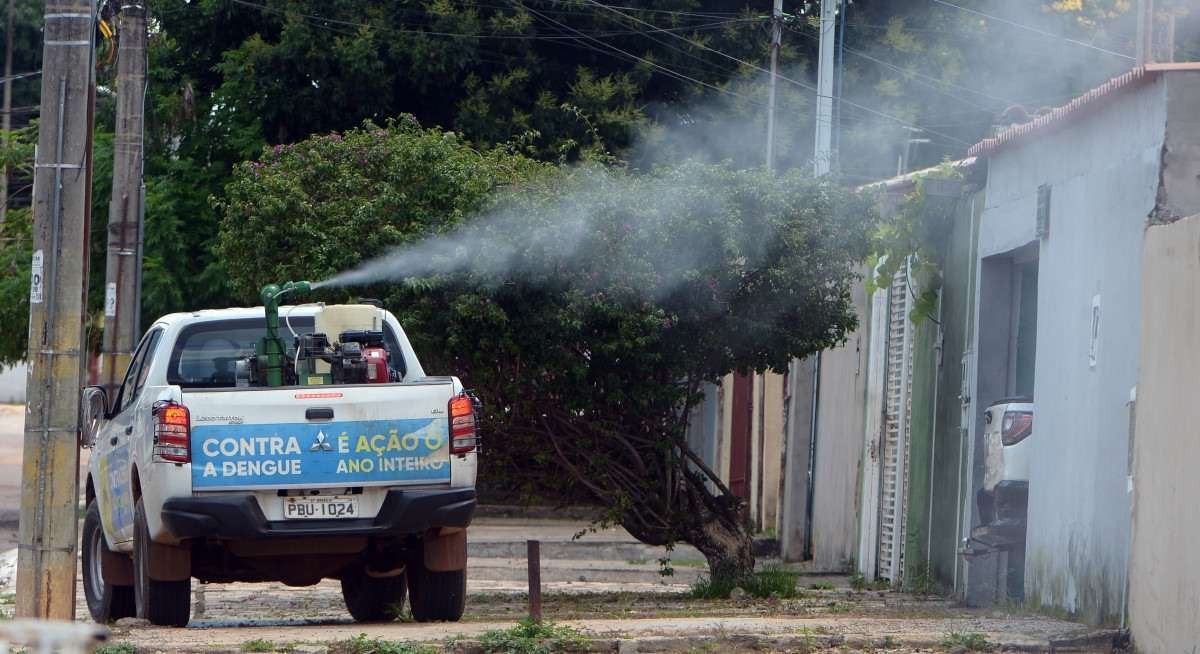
101 2 146 397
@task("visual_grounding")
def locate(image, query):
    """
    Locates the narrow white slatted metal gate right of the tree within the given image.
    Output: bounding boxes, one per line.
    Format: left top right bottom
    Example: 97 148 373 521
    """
876 264 912 584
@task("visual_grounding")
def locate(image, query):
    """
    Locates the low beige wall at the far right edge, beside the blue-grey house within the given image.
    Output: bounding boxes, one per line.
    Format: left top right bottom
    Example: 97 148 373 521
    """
1129 211 1200 652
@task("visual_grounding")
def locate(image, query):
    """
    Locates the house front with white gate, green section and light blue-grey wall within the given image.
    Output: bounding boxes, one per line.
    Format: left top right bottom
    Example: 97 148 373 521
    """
858 64 1200 636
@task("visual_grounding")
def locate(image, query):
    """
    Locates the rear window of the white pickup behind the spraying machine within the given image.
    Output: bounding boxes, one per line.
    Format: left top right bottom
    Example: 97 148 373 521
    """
167 316 407 389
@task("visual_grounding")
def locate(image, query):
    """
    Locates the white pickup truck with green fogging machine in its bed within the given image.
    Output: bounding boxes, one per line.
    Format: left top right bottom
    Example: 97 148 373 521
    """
80 305 478 626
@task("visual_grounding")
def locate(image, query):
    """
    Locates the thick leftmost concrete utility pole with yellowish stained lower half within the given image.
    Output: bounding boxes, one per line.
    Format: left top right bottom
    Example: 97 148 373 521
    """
17 0 96 619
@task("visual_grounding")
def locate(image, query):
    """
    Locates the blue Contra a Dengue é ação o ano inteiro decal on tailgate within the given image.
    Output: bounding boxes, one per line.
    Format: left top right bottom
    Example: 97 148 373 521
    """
192 418 450 488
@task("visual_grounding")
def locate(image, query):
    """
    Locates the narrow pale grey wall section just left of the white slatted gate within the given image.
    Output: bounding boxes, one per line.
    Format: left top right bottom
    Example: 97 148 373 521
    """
812 284 871 571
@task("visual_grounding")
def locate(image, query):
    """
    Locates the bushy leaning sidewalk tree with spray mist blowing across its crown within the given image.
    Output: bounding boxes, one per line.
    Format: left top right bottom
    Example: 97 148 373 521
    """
221 114 872 578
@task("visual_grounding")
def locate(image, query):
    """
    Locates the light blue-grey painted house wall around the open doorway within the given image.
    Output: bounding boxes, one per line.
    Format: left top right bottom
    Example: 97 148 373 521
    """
972 73 1168 622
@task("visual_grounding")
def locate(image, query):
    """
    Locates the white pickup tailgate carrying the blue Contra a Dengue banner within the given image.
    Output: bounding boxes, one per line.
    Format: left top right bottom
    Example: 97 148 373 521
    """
184 378 454 491
